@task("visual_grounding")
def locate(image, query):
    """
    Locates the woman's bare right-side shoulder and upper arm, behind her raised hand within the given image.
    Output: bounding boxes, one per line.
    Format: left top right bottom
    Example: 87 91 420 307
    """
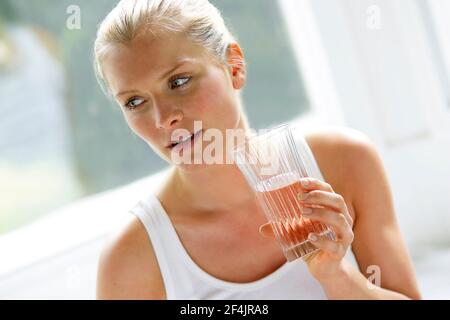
306 128 420 298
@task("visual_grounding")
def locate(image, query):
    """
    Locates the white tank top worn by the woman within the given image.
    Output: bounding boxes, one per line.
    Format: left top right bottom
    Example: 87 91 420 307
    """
130 127 354 300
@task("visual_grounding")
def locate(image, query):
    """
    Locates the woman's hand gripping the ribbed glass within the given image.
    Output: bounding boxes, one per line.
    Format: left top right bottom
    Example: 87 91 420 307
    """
259 178 354 279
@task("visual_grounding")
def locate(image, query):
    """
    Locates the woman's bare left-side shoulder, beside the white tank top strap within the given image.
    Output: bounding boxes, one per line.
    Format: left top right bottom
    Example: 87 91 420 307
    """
97 216 166 300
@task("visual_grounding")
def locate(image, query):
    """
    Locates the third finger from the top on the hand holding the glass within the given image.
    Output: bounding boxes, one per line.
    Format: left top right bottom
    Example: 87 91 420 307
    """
303 208 353 244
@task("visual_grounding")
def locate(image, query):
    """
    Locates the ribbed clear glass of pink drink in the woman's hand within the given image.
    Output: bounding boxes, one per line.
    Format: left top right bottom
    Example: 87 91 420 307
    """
233 124 335 261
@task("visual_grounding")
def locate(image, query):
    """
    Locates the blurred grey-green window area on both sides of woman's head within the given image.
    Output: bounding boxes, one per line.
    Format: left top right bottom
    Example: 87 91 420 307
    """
0 0 309 234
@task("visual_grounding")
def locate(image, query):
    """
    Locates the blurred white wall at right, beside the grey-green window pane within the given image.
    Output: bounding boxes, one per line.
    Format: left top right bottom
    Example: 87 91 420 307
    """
311 0 450 249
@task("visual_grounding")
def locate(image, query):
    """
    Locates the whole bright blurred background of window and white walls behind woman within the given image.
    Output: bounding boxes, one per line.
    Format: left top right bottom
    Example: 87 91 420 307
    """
0 0 450 299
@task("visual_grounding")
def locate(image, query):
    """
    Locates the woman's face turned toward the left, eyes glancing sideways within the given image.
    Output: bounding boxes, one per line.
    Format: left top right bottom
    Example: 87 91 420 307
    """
102 32 245 169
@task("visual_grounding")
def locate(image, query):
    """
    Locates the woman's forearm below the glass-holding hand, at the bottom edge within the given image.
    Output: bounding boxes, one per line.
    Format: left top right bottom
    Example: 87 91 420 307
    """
318 260 410 300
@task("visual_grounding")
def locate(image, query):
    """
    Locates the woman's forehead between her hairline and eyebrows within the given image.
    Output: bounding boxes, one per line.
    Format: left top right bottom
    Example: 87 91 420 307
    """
102 32 211 93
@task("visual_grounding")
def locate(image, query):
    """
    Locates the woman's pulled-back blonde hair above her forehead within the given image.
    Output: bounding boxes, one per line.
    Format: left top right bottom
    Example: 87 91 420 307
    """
94 0 239 95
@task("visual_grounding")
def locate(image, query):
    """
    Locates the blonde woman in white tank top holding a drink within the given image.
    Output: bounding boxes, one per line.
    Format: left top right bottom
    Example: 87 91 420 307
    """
95 0 420 299
